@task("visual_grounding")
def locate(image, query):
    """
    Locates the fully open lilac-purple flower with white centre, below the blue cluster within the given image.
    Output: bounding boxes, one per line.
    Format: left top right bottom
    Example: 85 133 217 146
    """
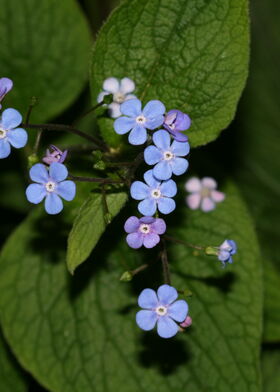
124 216 166 249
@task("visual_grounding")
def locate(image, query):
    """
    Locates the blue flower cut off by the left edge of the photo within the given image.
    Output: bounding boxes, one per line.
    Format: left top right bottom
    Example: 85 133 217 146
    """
0 109 28 159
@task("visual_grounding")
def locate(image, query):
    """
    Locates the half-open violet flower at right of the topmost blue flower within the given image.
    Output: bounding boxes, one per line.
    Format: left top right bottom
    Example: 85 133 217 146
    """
163 109 191 142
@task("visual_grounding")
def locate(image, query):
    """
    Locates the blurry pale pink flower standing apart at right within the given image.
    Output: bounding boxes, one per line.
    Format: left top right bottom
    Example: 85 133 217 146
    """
185 177 225 212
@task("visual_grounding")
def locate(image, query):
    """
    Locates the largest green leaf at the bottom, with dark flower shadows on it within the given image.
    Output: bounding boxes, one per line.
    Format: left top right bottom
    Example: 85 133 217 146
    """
0 181 262 392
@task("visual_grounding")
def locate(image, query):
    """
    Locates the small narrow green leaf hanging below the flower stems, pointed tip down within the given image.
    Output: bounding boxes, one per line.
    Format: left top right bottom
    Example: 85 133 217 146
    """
67 192 127 274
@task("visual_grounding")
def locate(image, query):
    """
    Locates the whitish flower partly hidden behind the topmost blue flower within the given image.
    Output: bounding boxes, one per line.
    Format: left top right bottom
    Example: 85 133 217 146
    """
97 78 136 118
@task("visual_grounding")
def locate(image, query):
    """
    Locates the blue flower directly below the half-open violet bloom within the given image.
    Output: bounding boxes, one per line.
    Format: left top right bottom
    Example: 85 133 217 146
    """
144 129 190 180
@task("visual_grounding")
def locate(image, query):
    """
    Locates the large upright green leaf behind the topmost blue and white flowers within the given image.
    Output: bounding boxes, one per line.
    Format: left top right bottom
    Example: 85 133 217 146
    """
91 0 249 147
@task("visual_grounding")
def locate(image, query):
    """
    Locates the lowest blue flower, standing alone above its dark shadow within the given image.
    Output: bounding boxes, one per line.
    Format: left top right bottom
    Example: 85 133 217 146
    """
136 284 189 338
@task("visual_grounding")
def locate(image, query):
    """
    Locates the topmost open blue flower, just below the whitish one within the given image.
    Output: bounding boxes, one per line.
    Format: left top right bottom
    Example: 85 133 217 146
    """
114 99 165 145
